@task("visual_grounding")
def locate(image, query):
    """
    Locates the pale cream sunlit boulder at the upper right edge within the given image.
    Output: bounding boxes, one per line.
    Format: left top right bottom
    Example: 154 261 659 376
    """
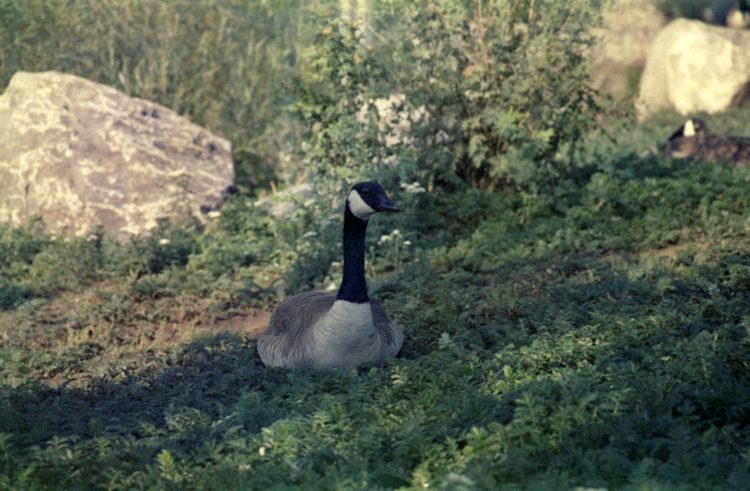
637 19 750 119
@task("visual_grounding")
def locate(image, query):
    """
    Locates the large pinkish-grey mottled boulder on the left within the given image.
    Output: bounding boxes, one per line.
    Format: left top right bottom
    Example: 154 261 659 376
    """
0 72 234 237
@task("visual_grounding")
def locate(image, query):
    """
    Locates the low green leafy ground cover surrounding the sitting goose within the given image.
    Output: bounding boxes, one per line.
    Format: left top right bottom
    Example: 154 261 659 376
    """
0 134 750 489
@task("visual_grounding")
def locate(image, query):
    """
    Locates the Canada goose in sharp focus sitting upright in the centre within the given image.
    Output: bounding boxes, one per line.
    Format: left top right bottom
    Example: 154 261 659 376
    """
258 182 404 371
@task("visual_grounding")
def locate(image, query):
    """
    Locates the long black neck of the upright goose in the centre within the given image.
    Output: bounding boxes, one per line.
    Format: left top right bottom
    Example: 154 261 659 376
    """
336 203 370 303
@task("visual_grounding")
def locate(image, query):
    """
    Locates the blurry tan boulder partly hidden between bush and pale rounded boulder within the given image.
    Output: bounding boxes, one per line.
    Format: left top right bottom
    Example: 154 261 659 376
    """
591 0 667 97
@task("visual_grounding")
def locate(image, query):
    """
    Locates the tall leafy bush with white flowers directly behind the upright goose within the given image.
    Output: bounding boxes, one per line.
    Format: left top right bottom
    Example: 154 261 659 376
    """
298 0 598 194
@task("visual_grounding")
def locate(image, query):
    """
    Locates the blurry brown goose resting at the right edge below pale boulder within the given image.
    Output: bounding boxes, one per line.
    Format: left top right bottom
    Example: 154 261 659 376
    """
667 119 750 165
